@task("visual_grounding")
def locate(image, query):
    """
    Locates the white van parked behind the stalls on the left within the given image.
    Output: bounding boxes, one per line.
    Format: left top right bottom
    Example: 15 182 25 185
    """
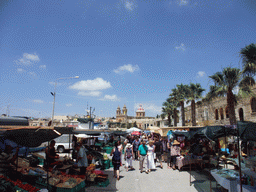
54 134 72 153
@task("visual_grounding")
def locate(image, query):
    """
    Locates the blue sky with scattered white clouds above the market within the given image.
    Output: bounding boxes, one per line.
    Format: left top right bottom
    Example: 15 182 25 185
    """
0 0 256 117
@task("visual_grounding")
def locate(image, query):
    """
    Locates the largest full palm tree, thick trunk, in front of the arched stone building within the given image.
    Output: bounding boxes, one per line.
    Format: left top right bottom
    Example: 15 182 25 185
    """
206 67 255 125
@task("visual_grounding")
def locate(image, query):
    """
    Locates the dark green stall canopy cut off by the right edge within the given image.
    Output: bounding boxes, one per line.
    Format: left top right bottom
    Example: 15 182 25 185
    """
237 121 256 141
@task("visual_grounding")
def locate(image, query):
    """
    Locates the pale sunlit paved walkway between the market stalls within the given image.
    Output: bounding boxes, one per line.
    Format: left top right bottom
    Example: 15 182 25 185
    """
86 154 220 192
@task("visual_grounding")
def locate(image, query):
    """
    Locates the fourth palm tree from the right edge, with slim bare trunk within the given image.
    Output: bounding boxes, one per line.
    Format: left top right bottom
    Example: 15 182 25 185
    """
170 83 189 126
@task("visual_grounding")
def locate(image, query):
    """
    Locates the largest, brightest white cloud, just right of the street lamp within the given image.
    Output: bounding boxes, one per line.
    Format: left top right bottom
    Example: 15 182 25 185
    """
69 78 112 91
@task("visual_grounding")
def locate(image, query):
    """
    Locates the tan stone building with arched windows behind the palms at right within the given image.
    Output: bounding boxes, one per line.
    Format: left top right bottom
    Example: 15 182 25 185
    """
185 87 256 126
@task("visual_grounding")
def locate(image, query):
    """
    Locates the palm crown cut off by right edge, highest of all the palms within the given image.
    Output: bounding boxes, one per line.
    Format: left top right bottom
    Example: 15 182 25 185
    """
240 43 256 77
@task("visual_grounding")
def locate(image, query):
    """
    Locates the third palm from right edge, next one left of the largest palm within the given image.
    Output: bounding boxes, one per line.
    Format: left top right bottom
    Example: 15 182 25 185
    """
188 83 205 126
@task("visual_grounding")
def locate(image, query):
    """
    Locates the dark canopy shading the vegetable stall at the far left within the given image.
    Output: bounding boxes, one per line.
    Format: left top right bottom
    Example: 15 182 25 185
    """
0 127 61 147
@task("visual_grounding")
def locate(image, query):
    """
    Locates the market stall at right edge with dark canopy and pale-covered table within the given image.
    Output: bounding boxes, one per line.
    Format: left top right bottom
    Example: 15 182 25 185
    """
211 122 256 192
